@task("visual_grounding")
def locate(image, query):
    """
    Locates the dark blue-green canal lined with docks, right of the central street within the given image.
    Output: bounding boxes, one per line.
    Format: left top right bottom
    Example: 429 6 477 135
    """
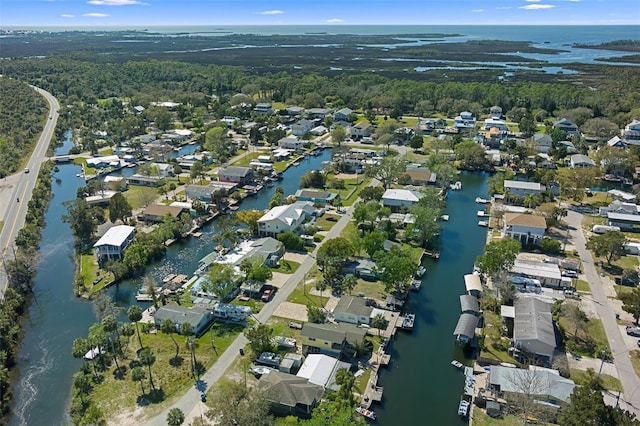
373 173 488 426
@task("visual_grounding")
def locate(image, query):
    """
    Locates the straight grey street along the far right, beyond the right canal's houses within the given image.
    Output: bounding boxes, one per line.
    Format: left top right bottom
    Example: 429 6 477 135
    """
567 210 640 416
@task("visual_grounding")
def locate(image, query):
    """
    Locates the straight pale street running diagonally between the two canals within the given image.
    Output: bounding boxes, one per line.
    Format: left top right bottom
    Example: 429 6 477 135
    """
145 180 379 426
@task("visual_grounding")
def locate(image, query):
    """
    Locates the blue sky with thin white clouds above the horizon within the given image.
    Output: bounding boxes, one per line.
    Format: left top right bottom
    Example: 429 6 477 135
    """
0 0 640 27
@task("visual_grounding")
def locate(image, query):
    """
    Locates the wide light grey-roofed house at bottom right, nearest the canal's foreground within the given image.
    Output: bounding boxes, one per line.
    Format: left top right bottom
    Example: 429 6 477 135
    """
489 365 576 406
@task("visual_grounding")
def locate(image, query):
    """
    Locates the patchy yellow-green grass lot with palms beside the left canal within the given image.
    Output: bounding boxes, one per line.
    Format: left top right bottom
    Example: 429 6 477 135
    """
91 323 243 417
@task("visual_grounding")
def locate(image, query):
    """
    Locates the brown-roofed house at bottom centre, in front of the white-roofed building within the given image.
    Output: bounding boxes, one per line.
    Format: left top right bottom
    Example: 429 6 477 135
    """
257 371 324 417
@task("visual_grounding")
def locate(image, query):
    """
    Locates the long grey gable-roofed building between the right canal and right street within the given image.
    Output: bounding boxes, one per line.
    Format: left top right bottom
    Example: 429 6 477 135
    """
513 298 557 365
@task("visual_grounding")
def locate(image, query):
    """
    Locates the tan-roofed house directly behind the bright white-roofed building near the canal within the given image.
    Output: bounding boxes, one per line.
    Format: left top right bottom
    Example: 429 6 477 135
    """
300 323 367 358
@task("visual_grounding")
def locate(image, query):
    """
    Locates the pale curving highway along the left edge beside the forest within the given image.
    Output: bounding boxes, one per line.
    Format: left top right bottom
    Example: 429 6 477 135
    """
0 86 60 299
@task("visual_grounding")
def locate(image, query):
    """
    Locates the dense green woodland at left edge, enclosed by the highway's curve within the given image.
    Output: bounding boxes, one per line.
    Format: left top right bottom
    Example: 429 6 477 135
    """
0 78 47 178
